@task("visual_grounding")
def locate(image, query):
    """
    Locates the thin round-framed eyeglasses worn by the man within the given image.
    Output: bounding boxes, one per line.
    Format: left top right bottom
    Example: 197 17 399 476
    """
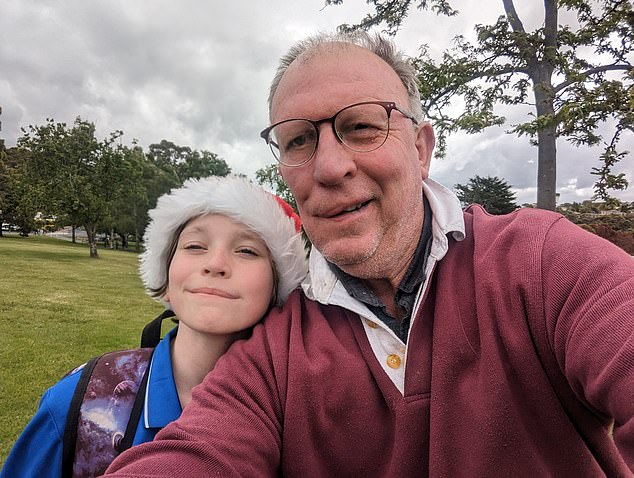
260 101 418 167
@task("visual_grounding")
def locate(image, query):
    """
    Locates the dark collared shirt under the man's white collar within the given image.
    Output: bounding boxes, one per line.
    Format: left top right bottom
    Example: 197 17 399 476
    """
330 196 432 343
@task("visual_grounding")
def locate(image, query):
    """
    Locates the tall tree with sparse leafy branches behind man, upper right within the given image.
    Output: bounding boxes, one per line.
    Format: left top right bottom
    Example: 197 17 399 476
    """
326 0 634 210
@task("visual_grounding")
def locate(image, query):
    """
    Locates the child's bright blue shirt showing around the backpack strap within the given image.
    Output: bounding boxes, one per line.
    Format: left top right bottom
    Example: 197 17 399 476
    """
0 327 182 478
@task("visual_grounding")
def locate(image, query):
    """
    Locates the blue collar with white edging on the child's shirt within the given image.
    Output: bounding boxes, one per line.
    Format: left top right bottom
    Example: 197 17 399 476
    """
144 327 182 428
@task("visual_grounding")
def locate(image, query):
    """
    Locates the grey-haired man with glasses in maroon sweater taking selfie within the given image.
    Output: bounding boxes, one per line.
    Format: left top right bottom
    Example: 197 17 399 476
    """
110 34 634 477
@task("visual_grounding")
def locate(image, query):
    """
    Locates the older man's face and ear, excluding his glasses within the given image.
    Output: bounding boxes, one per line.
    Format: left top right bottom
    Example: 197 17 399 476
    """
271 45 434 279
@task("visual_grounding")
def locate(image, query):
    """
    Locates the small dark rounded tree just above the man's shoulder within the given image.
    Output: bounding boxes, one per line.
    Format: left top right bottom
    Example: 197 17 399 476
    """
454 175 517 214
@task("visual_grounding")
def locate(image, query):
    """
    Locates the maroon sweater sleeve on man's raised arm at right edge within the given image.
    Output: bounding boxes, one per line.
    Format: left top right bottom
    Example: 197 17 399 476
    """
542 219 634 469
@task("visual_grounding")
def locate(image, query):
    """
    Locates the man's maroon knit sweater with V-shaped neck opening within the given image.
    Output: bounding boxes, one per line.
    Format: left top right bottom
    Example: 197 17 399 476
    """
109 208 634 478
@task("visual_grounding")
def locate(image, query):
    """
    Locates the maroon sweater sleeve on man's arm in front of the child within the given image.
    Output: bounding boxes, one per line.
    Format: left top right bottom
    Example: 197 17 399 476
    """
106 296 292 478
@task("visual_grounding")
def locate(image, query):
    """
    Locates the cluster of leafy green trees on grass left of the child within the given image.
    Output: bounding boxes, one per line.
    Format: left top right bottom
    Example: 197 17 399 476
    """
0 117 231 257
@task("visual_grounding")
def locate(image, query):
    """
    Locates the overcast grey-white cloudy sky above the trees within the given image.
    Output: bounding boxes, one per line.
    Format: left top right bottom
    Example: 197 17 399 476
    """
0 0 634 204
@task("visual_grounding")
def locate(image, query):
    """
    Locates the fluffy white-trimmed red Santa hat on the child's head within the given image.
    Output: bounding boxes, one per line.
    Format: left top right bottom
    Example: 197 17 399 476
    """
140 176 308 307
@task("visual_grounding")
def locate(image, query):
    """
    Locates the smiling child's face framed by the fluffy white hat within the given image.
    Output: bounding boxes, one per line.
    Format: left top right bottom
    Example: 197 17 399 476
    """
164 214 274 335
